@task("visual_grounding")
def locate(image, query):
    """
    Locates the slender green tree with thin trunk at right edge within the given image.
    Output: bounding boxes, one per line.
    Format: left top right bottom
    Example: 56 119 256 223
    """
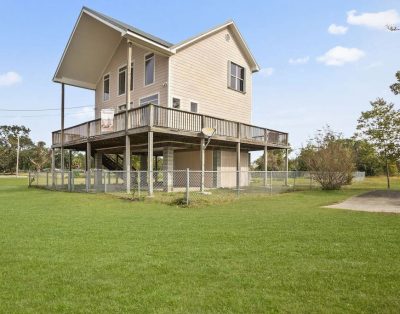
357 98 400 189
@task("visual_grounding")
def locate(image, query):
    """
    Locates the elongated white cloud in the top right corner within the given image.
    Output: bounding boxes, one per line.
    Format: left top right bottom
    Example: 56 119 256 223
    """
347 10 400 29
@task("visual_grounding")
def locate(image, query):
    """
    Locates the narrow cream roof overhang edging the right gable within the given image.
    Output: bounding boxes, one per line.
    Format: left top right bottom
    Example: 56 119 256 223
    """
171 21 260 72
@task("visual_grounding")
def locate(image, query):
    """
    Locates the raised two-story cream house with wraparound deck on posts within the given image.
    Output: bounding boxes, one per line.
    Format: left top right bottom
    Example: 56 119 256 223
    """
52 7 288 194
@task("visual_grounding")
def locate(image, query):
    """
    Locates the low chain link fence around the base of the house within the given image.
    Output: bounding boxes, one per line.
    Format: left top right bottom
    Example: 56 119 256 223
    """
29 169 365 204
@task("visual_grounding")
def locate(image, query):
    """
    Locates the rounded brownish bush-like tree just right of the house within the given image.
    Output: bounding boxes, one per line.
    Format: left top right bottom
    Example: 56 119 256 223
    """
302 127 354 190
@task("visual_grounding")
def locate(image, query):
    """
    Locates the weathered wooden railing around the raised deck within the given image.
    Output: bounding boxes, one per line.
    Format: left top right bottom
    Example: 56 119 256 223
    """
52 105 288 146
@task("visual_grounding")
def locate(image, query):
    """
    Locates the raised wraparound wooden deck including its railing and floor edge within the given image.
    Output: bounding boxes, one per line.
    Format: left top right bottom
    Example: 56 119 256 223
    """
52 104 288 150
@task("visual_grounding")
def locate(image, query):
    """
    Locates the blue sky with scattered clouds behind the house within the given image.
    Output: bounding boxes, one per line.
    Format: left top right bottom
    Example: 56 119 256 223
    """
0 0 400 156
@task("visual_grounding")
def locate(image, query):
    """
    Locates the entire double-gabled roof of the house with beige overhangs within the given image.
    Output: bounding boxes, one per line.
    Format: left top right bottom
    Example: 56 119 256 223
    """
53 7 259 89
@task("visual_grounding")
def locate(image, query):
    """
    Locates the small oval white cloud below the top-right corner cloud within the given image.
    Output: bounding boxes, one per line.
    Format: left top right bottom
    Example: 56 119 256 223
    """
317 46 365 66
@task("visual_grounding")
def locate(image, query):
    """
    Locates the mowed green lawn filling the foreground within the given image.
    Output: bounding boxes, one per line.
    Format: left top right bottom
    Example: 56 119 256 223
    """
0 178 400 313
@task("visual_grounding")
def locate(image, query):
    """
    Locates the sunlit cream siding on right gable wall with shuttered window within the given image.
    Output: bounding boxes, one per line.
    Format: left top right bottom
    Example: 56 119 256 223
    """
170 29 252 123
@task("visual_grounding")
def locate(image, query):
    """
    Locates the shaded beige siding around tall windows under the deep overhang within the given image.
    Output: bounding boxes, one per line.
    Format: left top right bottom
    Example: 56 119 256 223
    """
95 40 168 118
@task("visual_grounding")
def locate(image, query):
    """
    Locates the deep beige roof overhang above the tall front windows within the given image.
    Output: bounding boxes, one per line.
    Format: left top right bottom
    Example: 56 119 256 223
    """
53 8 172 90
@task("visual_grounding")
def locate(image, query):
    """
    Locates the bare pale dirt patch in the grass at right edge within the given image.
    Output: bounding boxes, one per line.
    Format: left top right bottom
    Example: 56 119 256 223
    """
325 190 400 213
